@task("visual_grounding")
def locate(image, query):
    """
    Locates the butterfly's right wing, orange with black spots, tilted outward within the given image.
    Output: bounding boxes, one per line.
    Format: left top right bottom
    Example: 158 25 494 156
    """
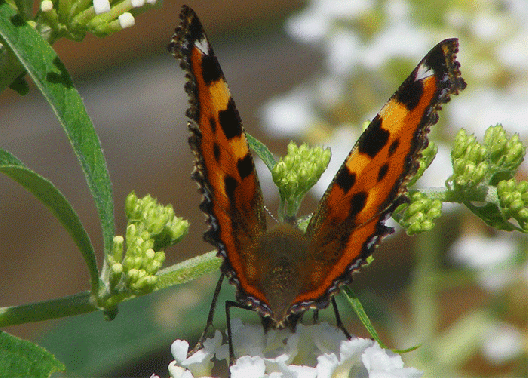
295 39 466 307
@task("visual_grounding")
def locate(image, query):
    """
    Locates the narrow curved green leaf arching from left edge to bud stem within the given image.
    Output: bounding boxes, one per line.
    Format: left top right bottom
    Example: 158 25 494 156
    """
0 149 99 292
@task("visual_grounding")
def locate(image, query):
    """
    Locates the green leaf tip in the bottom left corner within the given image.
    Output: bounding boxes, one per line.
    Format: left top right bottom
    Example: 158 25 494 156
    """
0 332 66 378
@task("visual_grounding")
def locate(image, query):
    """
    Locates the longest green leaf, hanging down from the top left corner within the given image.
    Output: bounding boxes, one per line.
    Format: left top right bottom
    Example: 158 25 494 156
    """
0 2 114 253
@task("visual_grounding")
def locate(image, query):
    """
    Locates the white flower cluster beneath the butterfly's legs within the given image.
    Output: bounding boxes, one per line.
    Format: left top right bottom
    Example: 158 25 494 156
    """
165 319 422 378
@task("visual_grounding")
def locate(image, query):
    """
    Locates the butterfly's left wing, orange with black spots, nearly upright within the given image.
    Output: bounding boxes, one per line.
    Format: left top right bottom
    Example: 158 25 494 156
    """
169 6 266 300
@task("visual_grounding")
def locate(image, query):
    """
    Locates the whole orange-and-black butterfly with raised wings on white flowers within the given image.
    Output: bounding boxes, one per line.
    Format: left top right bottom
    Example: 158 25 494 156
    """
169 6 466 361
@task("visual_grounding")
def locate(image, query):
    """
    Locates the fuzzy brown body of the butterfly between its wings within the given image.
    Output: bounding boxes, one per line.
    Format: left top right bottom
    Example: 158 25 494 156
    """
256 223 309 328
